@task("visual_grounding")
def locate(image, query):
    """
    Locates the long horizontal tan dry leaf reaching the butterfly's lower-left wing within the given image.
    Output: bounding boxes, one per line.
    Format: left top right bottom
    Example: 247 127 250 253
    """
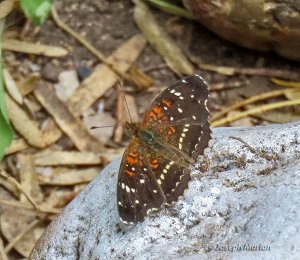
33 151 120 166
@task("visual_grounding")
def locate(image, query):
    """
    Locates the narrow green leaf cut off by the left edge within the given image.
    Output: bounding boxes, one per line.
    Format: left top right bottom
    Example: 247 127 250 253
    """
0 20 13 161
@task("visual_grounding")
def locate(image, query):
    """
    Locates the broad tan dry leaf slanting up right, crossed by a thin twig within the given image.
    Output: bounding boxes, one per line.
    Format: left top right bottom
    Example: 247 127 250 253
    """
68 35 146 116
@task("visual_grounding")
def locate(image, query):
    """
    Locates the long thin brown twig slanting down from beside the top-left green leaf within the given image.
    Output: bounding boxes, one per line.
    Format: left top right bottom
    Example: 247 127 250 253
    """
51 5 132 82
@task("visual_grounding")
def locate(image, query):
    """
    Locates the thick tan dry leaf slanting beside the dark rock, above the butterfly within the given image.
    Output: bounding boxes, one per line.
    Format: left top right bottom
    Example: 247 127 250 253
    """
133 0 194 75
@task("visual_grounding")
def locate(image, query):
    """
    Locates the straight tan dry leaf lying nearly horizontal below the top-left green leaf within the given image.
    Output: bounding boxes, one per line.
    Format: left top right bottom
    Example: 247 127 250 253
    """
2 39 68 57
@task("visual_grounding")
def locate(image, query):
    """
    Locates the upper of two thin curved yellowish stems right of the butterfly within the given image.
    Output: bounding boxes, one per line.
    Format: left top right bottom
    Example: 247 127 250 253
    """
210 89 294 122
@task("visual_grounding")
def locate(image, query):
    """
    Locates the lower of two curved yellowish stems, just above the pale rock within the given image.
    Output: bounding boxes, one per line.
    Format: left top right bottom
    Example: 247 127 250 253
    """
211 99 300 127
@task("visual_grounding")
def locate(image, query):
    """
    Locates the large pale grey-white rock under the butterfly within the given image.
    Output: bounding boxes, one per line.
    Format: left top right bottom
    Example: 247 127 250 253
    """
31 122 300 259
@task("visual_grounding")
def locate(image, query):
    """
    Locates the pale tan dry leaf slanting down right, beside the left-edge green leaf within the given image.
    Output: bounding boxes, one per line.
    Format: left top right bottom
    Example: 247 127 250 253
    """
6 96 45 148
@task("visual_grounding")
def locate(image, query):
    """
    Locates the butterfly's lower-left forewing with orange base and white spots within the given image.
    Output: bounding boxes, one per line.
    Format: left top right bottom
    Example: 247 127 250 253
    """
117 138 166 223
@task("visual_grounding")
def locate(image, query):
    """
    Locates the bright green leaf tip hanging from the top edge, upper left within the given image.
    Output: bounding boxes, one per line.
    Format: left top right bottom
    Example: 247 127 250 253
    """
20 0 53 26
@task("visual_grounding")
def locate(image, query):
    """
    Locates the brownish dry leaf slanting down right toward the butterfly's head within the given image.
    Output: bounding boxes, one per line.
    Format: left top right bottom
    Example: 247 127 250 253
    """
34 81 103 152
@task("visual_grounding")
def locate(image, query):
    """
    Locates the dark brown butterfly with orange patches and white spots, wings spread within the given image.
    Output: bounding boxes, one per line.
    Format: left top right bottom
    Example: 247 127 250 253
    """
117 74 211 224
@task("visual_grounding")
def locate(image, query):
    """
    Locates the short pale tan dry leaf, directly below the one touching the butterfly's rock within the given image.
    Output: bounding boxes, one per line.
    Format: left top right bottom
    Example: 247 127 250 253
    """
38 167 100 186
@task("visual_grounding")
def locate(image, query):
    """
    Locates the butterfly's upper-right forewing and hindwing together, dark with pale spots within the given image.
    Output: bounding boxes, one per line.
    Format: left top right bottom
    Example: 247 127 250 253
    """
142 75 211 159
